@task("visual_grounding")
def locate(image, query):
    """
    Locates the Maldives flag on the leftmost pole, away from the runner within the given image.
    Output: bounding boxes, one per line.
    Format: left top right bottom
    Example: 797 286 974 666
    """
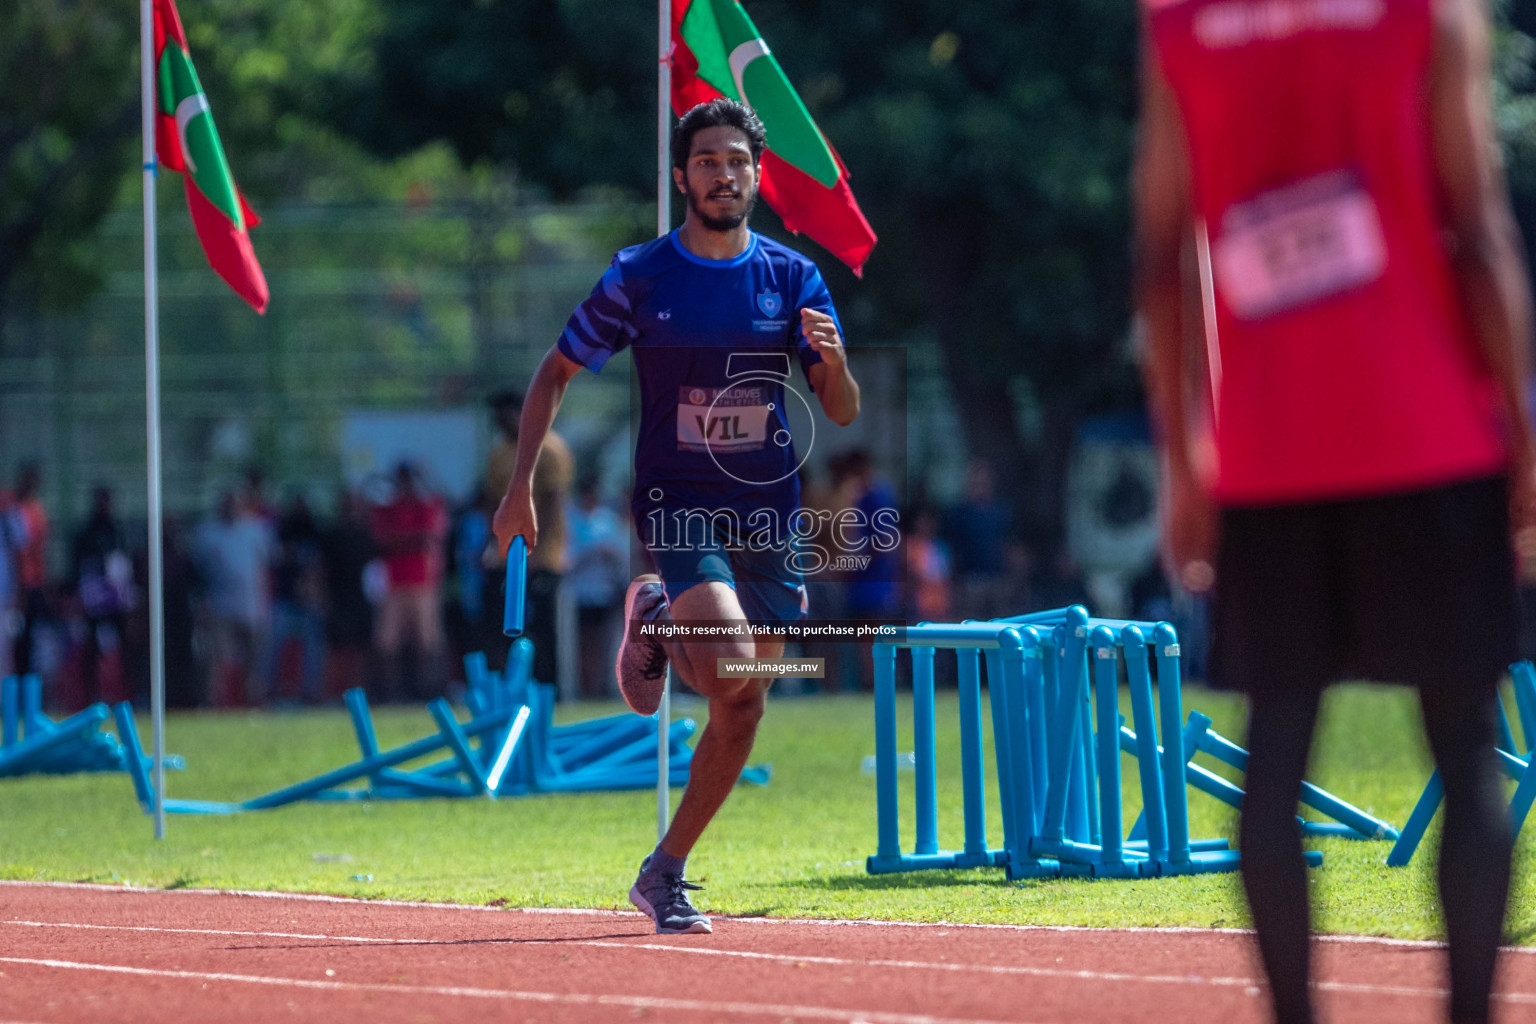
155 0 267 313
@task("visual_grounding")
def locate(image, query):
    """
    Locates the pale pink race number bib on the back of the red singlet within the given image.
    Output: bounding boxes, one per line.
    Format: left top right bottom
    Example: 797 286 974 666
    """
1210 170 1387 319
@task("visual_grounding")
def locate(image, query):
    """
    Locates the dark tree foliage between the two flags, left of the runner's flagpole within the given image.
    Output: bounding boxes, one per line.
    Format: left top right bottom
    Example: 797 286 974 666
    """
321 0 656 195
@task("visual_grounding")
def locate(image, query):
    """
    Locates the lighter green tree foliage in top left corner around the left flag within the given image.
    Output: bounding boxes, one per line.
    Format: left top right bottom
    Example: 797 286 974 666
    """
0 0 473 327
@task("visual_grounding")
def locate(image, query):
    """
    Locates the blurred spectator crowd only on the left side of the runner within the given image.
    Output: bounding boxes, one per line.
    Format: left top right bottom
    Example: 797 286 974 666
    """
0 391 642 711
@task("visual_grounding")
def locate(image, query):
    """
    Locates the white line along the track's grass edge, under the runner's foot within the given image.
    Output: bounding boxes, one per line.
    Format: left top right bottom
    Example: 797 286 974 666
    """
0 878 1536 955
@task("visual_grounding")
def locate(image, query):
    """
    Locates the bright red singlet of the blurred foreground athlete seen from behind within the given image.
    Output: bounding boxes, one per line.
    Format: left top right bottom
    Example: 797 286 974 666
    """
1147 0 1504 505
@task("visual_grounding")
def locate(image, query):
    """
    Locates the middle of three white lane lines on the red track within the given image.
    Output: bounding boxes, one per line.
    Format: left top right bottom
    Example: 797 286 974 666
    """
12 921 1536 1004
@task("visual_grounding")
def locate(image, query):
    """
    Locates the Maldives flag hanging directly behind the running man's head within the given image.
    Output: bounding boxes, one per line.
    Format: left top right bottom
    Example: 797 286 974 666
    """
671 0 876 273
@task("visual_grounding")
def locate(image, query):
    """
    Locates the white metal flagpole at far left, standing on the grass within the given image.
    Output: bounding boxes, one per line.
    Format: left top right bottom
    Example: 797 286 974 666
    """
142 0 166 840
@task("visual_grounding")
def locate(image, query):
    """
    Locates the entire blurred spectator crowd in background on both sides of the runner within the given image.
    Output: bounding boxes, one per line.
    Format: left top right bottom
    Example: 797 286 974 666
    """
0 391 1200 711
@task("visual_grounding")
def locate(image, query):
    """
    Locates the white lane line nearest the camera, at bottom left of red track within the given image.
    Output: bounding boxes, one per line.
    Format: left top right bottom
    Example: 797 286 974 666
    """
0 956 1044 1024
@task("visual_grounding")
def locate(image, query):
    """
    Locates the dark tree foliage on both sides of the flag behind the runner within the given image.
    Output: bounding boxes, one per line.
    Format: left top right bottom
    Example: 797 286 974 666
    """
332 0 1137 539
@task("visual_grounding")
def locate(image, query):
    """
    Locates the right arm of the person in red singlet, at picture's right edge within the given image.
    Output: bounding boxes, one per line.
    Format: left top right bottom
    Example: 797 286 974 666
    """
1430 0 1536 503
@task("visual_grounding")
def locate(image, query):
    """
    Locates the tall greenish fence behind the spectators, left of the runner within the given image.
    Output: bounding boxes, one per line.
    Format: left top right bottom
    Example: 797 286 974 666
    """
0 203 648 555
